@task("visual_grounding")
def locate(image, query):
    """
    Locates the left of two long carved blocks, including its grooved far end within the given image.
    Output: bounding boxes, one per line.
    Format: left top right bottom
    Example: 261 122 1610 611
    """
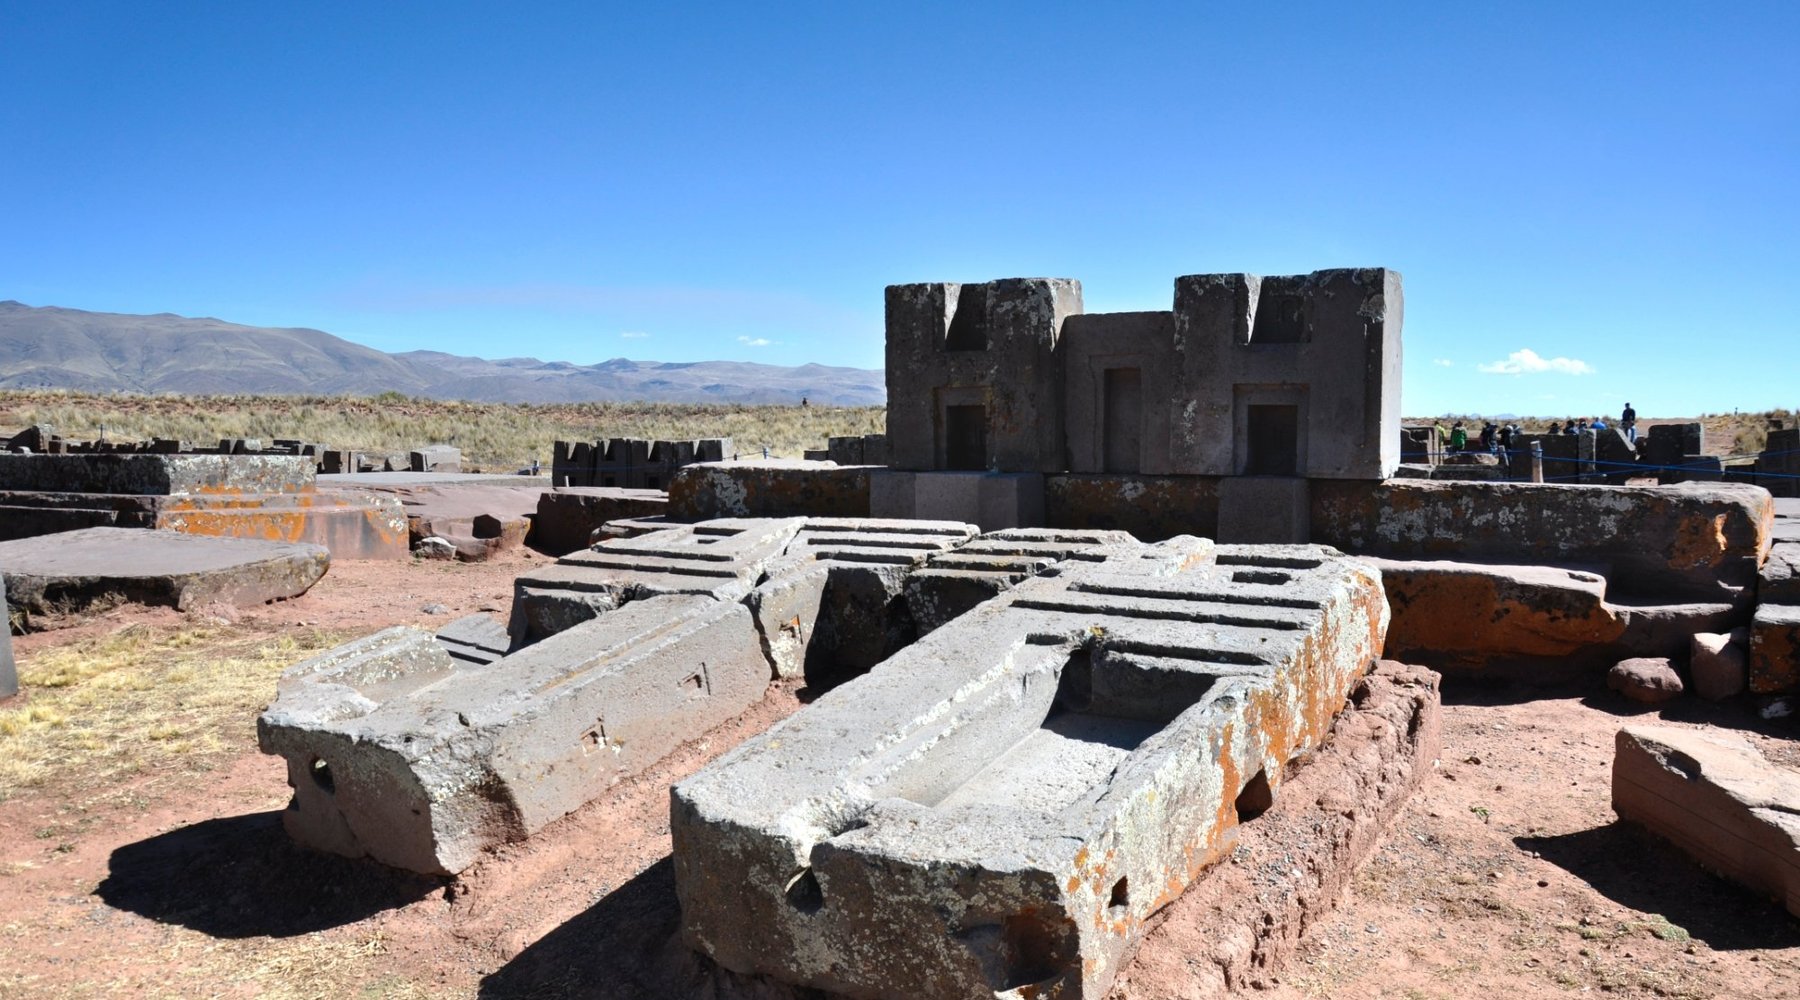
259 518 976 874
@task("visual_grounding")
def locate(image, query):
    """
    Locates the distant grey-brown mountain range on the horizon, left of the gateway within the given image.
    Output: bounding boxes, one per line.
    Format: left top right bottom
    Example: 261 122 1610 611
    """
0 300 887 406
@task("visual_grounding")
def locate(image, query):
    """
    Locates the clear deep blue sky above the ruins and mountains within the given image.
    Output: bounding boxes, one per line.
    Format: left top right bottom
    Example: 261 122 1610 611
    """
0 0 1800 415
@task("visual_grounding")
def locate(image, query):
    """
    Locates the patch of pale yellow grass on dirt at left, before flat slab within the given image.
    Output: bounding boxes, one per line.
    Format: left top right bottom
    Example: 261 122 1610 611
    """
0 624 346 800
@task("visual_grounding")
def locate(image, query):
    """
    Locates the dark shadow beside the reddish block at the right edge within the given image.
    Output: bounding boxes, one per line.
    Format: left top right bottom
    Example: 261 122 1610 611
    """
1514 820 1800 951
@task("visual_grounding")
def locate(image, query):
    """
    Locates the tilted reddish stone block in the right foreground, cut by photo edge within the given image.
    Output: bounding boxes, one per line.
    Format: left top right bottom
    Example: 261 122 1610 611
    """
1613 725 1800 917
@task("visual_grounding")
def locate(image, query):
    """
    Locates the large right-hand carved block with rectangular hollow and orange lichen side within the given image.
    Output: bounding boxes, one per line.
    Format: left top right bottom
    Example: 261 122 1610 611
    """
671 538 1388 998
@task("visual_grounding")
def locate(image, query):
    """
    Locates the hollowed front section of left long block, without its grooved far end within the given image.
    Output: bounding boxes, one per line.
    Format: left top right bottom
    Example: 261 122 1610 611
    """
257 595 772 874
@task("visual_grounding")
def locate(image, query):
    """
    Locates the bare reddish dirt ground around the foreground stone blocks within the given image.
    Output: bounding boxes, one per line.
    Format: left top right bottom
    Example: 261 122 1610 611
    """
0 558 1800 1000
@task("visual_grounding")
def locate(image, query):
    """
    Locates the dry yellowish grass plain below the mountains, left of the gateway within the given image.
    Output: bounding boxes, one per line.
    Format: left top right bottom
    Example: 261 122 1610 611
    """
0 392 887 471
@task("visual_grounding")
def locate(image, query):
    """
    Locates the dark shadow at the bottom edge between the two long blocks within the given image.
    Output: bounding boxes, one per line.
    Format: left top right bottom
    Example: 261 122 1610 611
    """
479 858 830 1000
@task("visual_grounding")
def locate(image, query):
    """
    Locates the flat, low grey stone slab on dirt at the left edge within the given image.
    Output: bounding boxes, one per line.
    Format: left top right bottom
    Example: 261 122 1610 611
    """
0 527 331 615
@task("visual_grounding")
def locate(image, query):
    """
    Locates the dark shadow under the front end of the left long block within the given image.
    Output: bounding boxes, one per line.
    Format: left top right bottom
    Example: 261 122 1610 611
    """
94 811 443 937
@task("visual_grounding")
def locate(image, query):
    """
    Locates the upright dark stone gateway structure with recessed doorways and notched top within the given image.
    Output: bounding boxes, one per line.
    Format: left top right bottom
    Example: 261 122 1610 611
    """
869 268 1404 541
